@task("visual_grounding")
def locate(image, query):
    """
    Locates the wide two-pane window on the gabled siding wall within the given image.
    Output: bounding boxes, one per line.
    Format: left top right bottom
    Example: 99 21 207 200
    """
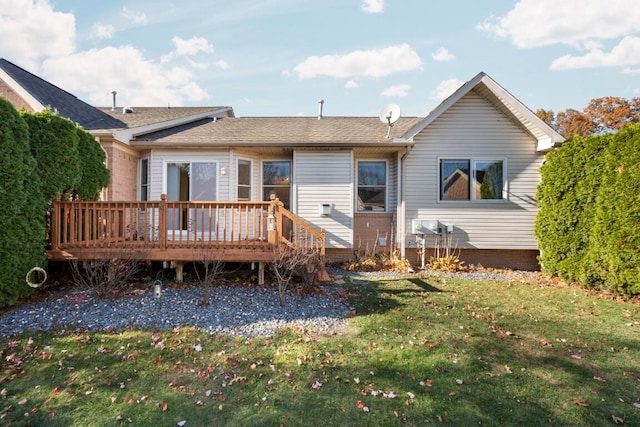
440 159 505 200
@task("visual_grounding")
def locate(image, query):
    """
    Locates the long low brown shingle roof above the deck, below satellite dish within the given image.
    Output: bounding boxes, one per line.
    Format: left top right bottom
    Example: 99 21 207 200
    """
131 116 421 151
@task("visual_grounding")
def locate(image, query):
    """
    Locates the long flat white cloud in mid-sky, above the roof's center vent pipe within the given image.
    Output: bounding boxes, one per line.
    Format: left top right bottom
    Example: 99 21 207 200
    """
293 44 422 79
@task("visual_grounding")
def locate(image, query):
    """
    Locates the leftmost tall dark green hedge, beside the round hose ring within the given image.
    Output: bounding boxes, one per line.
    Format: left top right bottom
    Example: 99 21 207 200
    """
0 98 46 307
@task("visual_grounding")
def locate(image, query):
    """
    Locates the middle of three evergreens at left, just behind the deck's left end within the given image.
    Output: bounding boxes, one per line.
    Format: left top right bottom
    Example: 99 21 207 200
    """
21 110 81 204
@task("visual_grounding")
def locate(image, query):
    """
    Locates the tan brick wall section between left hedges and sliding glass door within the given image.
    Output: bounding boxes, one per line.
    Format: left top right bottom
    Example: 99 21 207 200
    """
105 146 139 201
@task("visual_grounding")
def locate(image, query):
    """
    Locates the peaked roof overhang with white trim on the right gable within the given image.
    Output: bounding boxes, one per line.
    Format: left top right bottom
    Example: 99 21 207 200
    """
400 72 565 151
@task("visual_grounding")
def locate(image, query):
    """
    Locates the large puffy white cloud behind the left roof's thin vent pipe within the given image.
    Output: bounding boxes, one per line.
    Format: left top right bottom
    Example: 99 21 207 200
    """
42 46 206 106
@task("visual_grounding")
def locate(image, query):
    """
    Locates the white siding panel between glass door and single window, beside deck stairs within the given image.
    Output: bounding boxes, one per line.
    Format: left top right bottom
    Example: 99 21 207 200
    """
293 151 354 249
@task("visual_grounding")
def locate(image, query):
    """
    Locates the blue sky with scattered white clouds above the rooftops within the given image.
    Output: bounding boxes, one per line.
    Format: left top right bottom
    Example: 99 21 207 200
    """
0 0 640 117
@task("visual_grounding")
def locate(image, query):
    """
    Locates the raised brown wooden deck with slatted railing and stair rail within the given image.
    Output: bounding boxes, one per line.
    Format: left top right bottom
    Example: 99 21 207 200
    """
46 195 325 282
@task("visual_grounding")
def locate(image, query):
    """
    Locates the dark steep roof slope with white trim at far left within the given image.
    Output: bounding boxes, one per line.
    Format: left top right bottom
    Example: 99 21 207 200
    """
0 58 126 131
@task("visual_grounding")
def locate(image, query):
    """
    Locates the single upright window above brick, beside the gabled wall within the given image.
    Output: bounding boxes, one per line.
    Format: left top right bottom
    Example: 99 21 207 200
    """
357 161 387 212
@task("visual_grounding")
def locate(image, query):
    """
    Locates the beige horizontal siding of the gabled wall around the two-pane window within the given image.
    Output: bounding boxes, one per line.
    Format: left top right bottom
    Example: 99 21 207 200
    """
405 91 544 249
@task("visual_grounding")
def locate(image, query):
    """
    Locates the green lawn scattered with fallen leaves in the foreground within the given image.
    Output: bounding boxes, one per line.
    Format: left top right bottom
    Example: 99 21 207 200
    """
0 276 640 426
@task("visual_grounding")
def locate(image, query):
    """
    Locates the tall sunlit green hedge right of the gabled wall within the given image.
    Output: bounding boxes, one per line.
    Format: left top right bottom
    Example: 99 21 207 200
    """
535 125 640 294
